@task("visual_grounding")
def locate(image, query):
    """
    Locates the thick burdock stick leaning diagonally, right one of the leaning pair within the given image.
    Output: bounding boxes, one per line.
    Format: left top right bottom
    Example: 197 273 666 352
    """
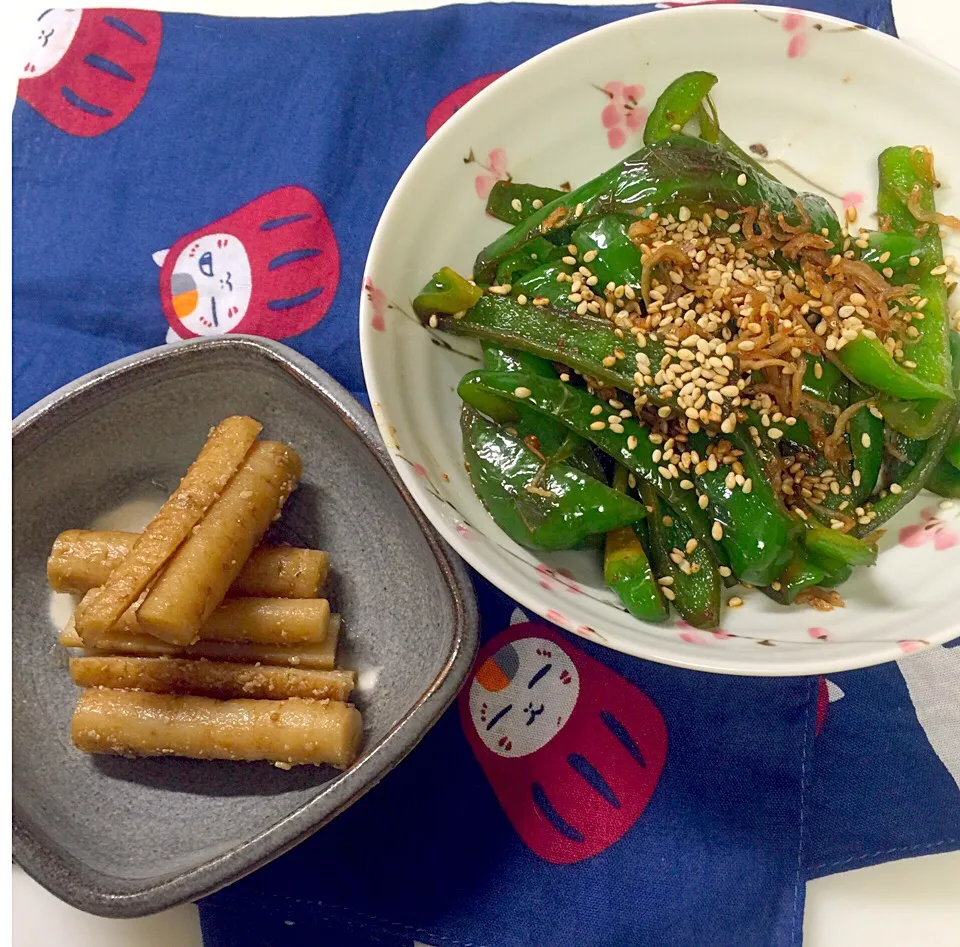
137 441 301 645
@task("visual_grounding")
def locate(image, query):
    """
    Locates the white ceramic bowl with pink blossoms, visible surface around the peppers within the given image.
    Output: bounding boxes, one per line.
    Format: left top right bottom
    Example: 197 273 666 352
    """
360 6 960 674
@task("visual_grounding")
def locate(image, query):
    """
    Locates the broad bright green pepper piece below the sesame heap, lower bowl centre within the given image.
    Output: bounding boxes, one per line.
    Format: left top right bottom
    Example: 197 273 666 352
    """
688 428 803 585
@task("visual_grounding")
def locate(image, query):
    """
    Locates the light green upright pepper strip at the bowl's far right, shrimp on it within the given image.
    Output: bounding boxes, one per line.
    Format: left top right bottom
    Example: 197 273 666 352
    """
877 145 954 399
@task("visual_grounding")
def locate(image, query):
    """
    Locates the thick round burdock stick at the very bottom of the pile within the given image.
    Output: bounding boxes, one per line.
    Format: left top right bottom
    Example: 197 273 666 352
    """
71 687 363 768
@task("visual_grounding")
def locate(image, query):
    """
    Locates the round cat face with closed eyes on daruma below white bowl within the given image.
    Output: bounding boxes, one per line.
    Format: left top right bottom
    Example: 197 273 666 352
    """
470 638 580 759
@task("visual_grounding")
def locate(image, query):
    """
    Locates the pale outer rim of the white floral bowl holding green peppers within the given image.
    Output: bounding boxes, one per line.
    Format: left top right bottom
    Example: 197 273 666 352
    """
359 2 960 677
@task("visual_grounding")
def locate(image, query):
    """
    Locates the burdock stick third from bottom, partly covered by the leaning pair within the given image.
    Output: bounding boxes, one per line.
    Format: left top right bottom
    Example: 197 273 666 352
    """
60 615 340 671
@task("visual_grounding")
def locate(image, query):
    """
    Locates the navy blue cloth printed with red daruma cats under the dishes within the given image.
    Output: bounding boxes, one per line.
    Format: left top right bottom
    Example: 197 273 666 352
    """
13 0 960 947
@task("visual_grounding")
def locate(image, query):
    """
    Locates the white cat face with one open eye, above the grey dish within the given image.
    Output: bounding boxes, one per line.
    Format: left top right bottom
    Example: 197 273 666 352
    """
169 233 252 335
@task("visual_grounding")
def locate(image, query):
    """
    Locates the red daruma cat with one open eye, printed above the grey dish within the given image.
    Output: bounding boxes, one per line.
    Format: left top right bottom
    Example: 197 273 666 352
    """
153 187 340 341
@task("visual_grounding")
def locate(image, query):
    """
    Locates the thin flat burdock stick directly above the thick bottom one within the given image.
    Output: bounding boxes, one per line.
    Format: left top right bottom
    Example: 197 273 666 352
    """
70 655 356 700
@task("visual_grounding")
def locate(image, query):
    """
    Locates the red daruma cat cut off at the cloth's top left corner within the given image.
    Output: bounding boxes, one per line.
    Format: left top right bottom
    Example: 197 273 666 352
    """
17 10 163 138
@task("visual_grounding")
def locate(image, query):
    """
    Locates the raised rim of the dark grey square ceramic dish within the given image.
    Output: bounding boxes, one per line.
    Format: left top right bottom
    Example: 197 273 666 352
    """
13 335 478 917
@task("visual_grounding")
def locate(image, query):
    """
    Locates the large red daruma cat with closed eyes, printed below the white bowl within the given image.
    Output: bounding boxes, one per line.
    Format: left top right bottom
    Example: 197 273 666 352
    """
460 622 667 864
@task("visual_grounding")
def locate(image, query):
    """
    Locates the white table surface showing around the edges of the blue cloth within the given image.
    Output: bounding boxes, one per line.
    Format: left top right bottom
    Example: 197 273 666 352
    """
11 0 960 947
